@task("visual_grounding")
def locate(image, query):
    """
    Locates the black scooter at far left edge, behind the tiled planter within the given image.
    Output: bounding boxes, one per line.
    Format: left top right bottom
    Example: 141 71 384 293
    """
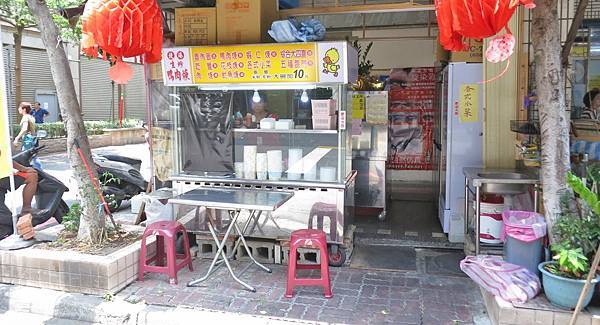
0 142 69 238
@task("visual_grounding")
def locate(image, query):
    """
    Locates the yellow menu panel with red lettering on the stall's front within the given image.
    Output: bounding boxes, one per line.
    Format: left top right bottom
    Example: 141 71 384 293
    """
190 43 319 84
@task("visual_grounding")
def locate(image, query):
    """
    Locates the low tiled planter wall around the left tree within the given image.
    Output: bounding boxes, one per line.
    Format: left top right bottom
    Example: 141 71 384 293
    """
0 227 156 295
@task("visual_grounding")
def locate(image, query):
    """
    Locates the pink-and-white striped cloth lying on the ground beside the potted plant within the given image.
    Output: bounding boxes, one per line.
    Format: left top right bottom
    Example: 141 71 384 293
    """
460 255 542 303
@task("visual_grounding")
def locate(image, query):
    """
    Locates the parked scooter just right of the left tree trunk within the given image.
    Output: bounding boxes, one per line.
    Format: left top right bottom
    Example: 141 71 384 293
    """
92 154 148 212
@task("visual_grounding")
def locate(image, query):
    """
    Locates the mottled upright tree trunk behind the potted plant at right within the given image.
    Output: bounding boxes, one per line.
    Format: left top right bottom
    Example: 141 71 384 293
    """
531 0 569 243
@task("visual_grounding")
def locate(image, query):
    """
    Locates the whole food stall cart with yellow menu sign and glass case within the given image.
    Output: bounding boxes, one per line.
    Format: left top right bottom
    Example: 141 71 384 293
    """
149 41 358 265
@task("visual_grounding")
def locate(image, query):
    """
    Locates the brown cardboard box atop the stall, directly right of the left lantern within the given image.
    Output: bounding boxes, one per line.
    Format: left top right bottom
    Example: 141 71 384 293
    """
175 8 217 46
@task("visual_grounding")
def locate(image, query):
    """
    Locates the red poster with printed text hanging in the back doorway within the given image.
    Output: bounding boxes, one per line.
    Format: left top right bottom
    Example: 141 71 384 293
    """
387 68 435 170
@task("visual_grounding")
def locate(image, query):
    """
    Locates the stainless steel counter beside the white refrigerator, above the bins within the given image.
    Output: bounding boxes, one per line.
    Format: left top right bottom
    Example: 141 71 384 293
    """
463 167 541 255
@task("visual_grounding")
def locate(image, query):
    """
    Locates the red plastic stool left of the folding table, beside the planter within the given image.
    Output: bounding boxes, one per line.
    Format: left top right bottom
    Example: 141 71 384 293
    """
138 221 193 284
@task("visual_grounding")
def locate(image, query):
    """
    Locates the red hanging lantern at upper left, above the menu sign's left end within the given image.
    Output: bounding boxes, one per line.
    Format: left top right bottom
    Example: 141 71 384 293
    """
81 0 163 84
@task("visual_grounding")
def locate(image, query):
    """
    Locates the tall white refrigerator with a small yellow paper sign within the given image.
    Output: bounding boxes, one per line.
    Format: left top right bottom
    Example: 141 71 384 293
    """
434 62 484 242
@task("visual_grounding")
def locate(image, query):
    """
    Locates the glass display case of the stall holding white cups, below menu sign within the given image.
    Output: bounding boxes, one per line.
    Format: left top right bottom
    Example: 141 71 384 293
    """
166 85 351 184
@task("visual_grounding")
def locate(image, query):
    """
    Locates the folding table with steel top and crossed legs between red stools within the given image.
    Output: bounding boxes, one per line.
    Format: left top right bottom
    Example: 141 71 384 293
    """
169 188 293 292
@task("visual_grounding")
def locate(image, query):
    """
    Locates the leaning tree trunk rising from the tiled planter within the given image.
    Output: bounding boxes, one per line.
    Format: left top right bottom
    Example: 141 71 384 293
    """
27 0 105 243
